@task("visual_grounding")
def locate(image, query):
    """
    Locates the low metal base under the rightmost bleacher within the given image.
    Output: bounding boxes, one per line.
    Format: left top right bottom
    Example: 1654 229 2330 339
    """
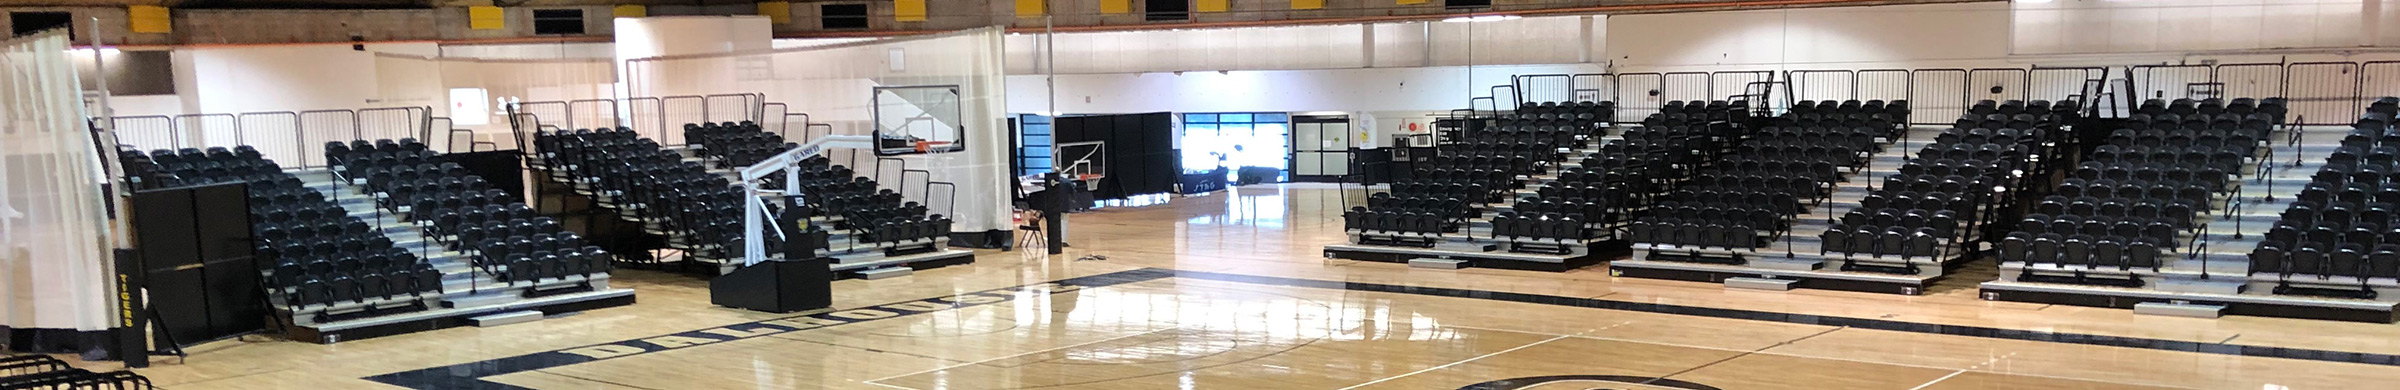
1982 282 2400 323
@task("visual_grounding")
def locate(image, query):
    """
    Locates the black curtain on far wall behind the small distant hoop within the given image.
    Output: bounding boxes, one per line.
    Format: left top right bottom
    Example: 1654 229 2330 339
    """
1051 113 1178 200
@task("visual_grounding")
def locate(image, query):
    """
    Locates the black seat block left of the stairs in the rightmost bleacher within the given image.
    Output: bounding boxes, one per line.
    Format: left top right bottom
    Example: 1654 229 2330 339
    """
1999 99 2280 286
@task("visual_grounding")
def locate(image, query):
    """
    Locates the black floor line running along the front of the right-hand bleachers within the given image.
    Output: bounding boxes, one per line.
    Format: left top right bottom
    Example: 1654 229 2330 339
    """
1176 270 2400 366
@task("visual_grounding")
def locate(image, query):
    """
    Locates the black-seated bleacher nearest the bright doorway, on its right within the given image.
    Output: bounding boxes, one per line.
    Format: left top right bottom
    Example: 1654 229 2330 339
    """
1325 101 1646 270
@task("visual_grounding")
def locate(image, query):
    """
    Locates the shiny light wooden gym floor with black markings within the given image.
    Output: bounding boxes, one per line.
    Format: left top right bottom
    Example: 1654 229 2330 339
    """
101 185 2400 390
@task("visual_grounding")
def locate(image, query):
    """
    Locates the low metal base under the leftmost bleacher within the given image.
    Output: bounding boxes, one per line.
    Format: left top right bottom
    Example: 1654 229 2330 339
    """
286 289 634 344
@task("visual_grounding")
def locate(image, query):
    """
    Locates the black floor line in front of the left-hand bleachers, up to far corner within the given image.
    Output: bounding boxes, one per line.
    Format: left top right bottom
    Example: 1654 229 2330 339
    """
365 267 1176 390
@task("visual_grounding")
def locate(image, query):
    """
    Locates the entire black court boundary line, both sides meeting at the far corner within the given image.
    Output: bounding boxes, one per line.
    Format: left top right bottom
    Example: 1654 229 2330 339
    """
365 267 2400 390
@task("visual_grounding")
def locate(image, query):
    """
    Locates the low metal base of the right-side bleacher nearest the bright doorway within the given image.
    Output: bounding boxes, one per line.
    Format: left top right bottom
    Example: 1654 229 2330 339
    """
1325 241 1632 272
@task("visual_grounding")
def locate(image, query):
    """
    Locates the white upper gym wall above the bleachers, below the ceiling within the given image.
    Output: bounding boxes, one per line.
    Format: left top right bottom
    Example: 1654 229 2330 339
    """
93 0 2400 123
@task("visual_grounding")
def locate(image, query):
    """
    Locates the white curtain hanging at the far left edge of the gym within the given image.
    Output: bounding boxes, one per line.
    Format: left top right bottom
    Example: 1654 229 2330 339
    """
0 31 113 330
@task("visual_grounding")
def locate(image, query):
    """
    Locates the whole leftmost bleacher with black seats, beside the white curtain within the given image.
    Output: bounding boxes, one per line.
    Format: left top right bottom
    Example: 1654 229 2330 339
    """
120 140 634 342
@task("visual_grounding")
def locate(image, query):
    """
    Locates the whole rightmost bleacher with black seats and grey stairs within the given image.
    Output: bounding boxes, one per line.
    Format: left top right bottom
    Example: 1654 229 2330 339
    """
1982 99 2400 323
